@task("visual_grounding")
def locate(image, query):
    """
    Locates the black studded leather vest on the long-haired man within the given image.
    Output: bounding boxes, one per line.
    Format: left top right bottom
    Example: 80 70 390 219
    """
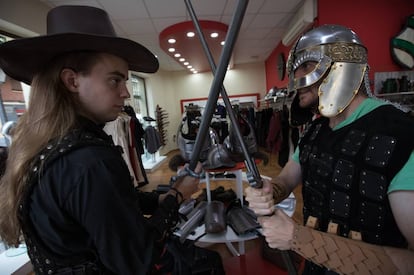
18 130 114 275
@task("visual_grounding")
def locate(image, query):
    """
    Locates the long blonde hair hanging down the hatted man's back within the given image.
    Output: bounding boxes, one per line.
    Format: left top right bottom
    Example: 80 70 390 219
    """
0 52 99 245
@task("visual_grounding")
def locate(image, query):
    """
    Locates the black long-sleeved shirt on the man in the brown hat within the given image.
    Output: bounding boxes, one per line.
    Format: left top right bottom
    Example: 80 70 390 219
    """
25 119 178 274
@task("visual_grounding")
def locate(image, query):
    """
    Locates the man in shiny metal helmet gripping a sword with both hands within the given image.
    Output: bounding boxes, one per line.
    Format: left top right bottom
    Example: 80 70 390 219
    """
246 25 414 274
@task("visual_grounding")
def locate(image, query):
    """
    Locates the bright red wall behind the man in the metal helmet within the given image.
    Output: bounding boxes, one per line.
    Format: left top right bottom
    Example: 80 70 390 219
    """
265 0 414 90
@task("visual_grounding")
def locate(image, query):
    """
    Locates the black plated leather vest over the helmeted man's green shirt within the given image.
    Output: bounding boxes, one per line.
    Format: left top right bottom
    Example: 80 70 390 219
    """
299 105 414 247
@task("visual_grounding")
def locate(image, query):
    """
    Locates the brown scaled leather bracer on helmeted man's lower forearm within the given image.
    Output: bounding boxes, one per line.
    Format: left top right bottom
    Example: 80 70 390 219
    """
292 222 398 275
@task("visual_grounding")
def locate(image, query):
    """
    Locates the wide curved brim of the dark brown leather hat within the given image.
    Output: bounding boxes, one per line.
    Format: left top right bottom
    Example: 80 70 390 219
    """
0 33 159 84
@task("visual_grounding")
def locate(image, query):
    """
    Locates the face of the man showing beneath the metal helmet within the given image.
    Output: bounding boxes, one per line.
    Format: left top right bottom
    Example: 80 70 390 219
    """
294 61 320 109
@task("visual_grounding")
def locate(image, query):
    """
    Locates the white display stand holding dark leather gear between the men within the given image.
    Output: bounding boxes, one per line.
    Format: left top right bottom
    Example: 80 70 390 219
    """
175 164 296 256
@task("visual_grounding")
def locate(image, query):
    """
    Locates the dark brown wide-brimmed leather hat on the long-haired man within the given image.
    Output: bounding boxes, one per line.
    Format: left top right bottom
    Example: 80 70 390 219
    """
0 6 159 84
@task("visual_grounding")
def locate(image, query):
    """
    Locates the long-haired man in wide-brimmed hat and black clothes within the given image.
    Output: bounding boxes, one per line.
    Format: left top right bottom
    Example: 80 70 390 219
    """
0 6 222 274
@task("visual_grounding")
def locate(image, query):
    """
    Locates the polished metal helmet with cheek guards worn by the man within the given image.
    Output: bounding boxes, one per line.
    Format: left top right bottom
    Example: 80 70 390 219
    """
287 25 370 117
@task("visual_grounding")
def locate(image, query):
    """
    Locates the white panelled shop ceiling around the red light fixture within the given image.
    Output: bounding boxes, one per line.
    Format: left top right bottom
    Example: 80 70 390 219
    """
40 0 303 71
